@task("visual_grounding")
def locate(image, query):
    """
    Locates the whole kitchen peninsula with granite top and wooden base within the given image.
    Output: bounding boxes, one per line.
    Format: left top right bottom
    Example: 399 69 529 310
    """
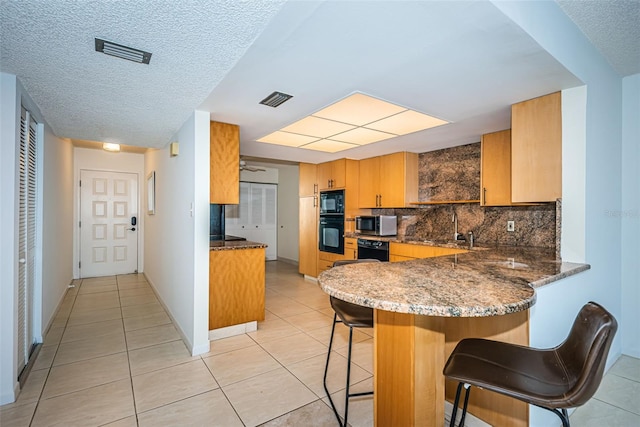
318 247 590 426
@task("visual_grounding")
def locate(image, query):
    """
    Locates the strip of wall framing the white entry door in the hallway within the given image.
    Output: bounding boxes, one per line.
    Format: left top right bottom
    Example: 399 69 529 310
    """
72 148 146 279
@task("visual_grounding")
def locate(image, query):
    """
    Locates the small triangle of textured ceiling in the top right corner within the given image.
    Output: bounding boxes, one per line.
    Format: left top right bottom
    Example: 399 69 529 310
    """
558 0 640 76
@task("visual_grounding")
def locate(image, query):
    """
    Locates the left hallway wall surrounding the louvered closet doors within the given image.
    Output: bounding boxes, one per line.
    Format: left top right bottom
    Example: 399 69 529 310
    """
0 73 73 404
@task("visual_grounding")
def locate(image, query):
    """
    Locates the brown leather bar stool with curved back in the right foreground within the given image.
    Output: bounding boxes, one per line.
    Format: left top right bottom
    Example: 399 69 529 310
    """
443 302 618 427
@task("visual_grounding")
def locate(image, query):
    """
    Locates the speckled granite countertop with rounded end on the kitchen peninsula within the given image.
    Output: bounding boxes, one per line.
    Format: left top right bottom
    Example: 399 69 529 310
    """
318 246 590 317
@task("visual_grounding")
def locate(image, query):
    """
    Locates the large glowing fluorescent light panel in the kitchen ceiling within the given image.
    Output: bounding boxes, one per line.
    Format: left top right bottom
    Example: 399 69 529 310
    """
257 93 448 153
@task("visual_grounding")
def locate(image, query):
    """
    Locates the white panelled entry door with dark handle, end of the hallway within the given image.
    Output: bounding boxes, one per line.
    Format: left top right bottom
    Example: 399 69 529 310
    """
80 170 138 277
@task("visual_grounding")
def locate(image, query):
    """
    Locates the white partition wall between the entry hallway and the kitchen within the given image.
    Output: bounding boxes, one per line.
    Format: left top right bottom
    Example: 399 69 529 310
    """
143 111 209 355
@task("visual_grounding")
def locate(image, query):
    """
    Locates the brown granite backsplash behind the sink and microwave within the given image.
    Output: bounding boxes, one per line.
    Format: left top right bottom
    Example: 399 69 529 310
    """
372 142 560 251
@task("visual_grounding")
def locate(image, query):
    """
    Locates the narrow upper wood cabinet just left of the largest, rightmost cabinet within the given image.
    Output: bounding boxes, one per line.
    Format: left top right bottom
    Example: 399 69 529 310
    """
480 129 511 206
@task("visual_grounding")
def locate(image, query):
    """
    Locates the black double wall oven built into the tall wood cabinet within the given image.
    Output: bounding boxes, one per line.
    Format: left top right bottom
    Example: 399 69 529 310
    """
318 190 344 255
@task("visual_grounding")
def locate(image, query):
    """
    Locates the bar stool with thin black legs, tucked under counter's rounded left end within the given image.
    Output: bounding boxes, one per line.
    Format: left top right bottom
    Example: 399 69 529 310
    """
323 259 380 427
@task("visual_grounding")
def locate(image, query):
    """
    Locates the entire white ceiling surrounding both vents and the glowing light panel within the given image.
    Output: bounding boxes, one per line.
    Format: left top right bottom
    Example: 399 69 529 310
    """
0 0 638 163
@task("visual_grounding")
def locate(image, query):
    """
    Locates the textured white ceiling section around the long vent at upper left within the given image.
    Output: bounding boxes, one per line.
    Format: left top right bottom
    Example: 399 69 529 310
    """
0 0 282 147
